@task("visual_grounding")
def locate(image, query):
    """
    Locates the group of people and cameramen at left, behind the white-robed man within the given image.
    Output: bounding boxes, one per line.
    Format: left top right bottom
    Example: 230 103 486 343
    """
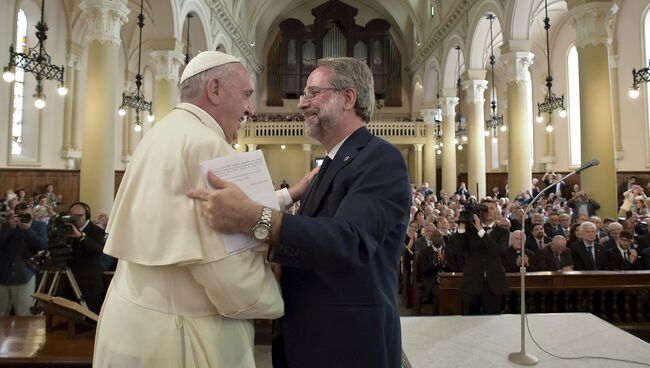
0 184 114 317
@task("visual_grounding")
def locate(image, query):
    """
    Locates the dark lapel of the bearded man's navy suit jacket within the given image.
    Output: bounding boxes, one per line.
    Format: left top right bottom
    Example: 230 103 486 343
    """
300 127 372 216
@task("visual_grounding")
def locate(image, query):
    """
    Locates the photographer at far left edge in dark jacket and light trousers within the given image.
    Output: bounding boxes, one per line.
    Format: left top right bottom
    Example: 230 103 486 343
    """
0 203 47 317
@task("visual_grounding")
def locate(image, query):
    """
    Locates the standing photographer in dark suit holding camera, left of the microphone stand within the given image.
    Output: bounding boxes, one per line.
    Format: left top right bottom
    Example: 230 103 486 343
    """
456 199 510 315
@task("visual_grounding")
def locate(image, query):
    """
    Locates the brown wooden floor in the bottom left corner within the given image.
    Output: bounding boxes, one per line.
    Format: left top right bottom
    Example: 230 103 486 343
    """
0 316 94 367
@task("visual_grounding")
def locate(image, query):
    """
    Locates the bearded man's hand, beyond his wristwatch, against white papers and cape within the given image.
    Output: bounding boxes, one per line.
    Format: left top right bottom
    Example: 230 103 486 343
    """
187 172 262 233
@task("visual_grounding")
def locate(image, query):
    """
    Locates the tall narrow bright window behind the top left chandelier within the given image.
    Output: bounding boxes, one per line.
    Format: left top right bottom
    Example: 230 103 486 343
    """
11 9 27 155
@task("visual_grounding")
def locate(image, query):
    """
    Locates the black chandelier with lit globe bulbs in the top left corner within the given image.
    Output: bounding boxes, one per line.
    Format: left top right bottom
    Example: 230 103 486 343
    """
2 0 68 109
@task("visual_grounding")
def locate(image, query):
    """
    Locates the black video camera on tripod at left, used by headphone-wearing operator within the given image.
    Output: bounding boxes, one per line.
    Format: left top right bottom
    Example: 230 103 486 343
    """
27 215 80 270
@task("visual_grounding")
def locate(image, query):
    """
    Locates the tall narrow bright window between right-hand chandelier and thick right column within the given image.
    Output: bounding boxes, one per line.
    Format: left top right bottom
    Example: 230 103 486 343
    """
567 45 582 166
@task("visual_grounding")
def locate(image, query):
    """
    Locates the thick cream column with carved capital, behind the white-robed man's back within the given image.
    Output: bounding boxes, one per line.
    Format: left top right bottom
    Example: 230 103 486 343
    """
79 0 129 213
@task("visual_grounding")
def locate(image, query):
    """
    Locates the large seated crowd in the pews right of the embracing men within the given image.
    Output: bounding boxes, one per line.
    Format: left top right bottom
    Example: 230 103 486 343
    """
402 177 650 314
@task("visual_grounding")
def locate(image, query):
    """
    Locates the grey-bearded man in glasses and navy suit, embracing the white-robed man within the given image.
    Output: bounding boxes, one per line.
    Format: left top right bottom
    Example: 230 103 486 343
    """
188 58 411 368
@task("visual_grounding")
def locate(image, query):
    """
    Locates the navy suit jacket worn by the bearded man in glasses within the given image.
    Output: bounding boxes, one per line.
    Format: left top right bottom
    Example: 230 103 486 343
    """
270 127 411 368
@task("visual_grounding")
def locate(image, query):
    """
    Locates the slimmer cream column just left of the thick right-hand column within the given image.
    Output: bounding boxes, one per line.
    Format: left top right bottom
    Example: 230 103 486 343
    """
501 41 534 200
